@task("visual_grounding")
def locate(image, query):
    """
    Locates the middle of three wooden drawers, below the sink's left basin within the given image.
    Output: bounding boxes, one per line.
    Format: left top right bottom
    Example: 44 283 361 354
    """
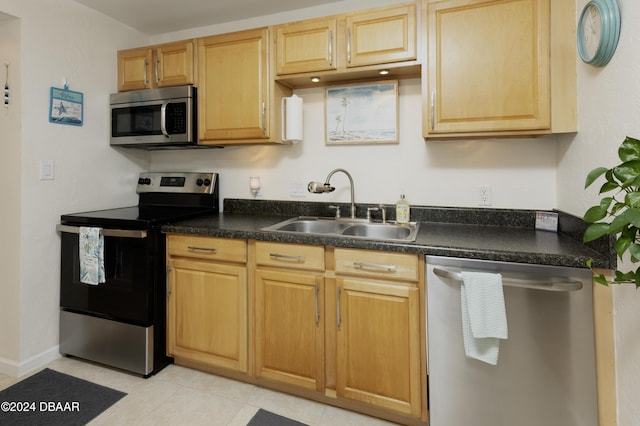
256 241 324 271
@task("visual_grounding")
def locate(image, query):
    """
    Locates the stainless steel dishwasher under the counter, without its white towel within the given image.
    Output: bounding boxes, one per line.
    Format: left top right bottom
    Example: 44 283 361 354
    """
426 256 598 426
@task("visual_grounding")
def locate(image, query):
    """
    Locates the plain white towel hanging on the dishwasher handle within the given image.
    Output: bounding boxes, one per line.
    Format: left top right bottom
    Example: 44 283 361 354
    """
460 272 508 365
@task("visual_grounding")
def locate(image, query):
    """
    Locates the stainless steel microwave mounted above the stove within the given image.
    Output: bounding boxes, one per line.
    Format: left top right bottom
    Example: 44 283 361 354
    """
110 86 198 149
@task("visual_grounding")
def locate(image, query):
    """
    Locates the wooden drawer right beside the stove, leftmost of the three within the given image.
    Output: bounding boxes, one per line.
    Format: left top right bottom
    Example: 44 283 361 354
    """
167 235 247 263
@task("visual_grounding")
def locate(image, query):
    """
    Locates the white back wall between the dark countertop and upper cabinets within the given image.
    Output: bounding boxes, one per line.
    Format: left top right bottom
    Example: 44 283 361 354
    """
152 79 556 209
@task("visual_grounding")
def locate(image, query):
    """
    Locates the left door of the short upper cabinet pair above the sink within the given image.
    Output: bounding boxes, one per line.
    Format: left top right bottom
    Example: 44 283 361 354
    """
276 18 337 75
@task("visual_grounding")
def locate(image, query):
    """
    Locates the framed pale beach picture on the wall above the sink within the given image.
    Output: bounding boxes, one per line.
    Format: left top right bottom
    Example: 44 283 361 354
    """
325 80 399 145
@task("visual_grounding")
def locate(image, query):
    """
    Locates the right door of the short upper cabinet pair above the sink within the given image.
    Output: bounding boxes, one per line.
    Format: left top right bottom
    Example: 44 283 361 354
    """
346 4 417 67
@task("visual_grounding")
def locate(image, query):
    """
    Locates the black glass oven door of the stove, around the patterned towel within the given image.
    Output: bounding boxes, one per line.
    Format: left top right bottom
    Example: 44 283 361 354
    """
60 232 162 325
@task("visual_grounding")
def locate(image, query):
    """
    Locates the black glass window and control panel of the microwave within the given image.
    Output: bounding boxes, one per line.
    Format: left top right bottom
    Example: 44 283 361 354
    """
111 102 187 137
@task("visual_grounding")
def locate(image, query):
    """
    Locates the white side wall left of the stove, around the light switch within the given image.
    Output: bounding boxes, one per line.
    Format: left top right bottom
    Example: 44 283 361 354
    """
0 0 149 375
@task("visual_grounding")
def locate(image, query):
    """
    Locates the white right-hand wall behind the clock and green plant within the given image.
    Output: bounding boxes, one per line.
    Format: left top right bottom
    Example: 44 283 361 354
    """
558 0 640 426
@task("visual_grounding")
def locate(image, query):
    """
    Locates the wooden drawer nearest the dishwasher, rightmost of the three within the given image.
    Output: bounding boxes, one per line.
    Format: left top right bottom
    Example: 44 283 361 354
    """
334 248 419 281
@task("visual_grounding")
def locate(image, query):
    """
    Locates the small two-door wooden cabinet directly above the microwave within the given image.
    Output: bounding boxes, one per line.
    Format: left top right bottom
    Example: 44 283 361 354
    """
118 40 196 92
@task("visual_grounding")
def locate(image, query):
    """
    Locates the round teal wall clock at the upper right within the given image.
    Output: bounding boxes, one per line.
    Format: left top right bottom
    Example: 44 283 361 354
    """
578 0 620 67
